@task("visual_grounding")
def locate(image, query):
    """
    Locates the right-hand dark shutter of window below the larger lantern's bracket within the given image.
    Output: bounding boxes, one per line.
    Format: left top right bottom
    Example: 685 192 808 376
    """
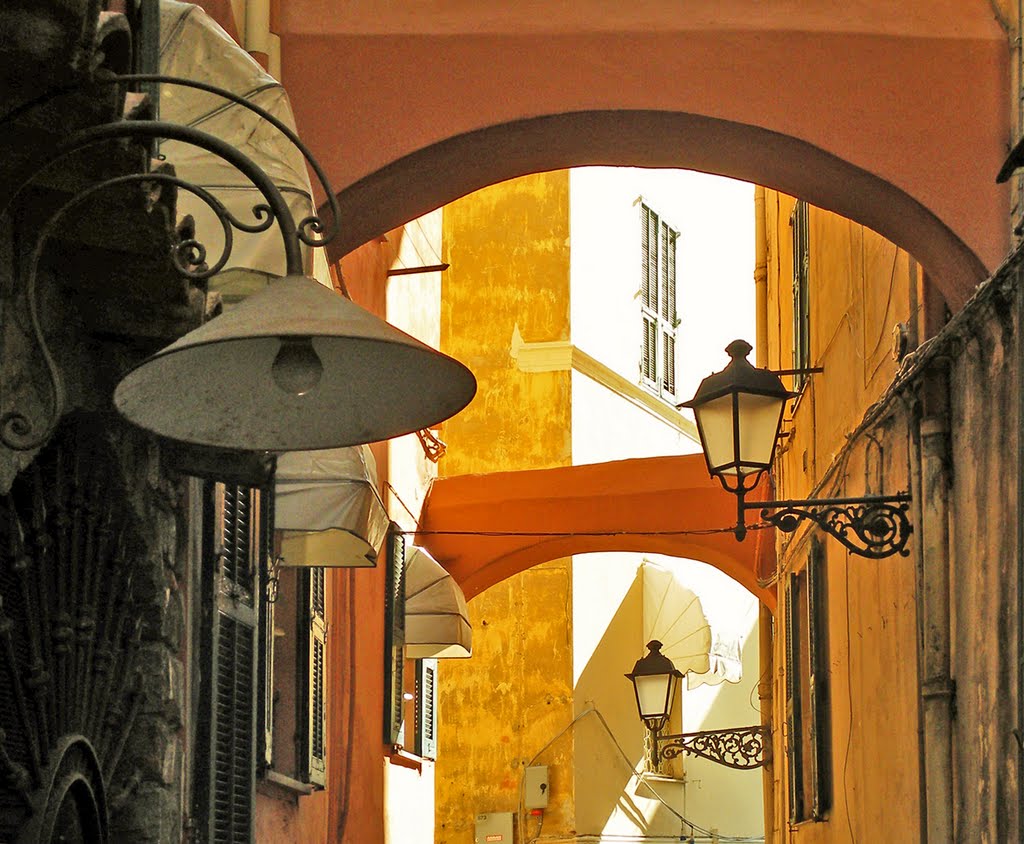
807 540 831 820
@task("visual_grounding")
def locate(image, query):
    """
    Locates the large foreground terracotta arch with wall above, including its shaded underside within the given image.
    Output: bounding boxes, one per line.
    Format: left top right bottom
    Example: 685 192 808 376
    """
274 8 1012 307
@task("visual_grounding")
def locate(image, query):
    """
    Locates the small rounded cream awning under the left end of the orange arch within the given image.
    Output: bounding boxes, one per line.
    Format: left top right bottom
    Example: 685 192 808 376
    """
406 546 473 660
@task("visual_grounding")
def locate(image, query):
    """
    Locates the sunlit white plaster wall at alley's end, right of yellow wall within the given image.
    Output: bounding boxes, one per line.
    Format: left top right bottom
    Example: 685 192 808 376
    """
569 167 763 840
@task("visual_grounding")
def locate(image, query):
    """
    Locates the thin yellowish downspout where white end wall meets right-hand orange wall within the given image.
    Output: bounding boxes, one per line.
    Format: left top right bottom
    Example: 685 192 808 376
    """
754 184 775 844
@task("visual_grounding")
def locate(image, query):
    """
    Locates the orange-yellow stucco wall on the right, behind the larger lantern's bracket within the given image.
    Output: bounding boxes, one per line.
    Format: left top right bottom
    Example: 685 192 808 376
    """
763 191 920 844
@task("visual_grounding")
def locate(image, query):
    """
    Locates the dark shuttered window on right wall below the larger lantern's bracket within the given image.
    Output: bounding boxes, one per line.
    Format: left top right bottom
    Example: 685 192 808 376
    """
785 541 831 822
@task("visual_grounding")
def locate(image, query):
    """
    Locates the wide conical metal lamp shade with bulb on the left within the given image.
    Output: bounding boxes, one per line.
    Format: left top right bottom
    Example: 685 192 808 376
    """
114 276 476 452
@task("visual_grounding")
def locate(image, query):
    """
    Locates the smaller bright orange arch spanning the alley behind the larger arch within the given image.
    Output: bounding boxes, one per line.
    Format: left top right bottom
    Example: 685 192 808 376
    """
417 455 775 607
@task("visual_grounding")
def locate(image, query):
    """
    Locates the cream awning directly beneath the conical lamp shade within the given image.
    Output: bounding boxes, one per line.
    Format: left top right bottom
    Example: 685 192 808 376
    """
273 446 388 567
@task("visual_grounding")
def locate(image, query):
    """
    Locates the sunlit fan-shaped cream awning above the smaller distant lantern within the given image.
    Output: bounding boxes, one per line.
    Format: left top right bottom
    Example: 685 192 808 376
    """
641 561 741 688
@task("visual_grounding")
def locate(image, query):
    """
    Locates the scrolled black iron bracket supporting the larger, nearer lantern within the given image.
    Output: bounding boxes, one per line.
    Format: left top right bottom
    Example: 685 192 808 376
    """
740 493 913 559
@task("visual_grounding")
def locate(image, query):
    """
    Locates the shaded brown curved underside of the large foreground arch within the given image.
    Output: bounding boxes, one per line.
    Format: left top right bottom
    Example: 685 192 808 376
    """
323 111 988 308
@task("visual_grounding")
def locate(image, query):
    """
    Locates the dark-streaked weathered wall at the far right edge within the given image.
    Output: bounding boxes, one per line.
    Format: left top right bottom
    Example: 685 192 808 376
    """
946 267 1021 842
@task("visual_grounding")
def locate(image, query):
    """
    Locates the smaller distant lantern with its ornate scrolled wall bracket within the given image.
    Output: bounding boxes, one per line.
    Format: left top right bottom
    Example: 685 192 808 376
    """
626 640 770 770
